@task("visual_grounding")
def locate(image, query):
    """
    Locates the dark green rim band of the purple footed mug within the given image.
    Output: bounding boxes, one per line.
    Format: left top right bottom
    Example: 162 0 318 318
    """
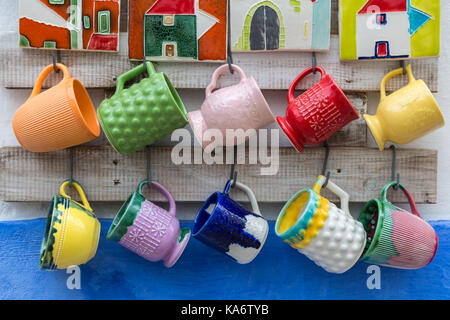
106 191 146 242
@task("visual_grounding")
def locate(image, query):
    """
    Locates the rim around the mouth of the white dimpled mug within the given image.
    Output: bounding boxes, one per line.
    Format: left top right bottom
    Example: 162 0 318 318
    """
275 188 316 240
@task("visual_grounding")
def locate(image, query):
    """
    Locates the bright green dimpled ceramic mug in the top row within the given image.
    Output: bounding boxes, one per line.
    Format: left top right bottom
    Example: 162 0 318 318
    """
97 61 188 154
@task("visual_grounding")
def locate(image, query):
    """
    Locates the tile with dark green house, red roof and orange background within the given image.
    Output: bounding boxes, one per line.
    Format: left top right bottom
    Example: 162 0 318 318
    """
128 0 227 61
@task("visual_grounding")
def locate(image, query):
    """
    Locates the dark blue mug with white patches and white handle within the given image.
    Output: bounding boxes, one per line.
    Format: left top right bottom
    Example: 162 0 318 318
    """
192 180 269 264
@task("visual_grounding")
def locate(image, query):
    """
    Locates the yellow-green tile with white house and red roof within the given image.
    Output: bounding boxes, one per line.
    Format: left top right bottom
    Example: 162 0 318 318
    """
339 0 440 60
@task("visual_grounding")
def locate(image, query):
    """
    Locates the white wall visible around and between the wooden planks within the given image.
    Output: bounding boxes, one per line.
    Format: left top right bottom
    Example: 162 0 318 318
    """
0 0 450 220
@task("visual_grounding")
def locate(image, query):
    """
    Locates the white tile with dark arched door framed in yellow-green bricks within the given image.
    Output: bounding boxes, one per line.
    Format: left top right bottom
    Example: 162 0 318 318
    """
231 0 331 51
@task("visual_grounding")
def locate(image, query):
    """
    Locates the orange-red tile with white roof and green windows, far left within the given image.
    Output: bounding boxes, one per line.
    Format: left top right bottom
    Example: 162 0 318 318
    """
19 0 120 51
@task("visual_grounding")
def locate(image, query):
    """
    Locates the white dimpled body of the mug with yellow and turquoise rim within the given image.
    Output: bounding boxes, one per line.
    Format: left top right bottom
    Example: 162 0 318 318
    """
298 202 366 273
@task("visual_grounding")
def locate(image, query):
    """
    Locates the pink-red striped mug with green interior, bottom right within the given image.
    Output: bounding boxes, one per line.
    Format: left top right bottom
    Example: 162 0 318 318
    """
358 181 439 269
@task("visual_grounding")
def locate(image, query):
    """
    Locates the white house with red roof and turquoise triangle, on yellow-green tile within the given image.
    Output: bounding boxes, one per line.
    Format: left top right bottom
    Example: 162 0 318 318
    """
356 0 431 60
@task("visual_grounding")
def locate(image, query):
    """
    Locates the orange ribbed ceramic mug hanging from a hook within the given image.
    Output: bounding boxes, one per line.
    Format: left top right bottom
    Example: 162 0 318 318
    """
12 63 100 152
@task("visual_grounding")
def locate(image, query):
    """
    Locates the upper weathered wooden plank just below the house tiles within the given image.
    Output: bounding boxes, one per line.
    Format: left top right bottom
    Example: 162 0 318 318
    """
0 32 438 92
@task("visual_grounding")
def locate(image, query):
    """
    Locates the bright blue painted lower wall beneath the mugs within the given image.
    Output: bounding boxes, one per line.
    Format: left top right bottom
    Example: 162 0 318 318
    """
0 219 450 299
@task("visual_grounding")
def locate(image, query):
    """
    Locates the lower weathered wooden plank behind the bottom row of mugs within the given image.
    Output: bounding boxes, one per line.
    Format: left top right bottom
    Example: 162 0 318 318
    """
0 147 437 203
